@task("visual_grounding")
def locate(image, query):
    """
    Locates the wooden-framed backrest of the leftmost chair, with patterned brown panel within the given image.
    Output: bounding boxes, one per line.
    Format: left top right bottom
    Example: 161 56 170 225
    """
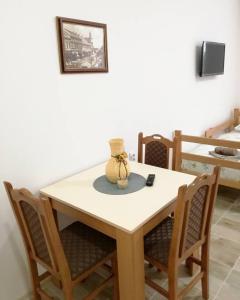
4 182 70 275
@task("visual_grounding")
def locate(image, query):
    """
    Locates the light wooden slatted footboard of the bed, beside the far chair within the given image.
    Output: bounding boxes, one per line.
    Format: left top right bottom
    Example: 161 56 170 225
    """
174 129 240 189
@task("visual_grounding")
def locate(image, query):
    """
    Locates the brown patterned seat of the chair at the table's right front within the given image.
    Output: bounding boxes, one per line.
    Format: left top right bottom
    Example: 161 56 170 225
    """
144 217 173 266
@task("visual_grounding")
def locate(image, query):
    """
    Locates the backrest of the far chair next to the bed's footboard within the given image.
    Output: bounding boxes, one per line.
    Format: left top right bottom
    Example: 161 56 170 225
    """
138 132 175 169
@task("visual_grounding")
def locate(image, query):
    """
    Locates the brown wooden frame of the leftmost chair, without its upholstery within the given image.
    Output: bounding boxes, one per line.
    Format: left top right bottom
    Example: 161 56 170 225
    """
4 182 119 300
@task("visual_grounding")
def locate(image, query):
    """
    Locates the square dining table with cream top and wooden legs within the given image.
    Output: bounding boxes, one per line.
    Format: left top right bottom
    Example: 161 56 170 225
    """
40 162 196 300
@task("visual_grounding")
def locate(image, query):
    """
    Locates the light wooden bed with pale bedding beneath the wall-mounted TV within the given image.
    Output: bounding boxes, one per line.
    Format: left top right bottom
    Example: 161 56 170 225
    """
174 109 240 189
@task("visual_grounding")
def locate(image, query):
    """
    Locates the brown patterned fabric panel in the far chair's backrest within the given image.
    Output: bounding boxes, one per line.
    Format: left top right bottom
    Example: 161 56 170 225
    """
145 142 168 169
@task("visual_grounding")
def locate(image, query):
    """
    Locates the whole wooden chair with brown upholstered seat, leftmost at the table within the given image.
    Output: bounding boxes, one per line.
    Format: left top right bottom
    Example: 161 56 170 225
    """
4 182 119 300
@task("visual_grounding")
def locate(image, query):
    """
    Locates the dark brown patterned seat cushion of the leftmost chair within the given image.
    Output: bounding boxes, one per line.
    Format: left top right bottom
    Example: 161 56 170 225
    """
60 222 116 278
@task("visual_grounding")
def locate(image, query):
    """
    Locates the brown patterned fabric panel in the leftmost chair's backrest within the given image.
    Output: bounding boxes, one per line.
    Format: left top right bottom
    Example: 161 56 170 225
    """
20 201 51 266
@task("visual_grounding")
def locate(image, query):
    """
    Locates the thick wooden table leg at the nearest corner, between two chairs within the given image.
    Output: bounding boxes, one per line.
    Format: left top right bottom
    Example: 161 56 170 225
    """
116 229 145 300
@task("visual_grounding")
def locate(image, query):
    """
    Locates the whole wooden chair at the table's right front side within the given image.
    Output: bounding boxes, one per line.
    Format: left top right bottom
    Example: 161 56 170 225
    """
144 167 220 300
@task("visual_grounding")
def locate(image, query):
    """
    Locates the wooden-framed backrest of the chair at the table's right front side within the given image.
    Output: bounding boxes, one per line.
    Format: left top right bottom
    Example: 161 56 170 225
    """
169 167 220 260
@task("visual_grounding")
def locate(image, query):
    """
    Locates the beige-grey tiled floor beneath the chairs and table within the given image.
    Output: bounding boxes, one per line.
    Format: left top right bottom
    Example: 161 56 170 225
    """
41 188 240 300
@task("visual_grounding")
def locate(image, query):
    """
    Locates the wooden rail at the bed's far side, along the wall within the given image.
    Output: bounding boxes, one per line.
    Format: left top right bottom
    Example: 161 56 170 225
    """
205 108 240 138
